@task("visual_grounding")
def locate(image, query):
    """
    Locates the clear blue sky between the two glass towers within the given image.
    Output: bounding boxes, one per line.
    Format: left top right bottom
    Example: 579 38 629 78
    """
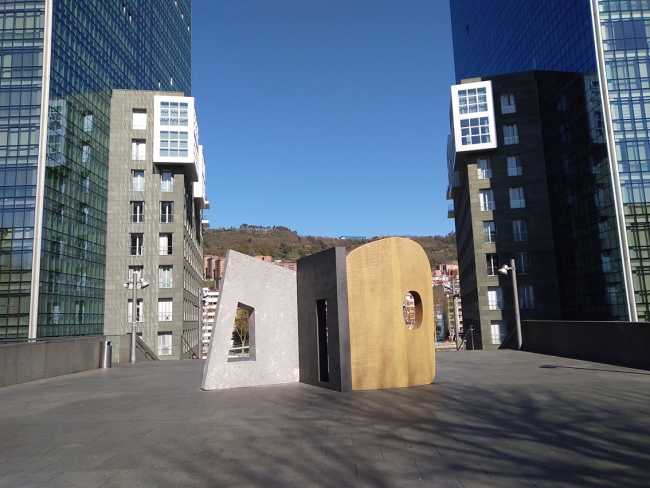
192 0 454 237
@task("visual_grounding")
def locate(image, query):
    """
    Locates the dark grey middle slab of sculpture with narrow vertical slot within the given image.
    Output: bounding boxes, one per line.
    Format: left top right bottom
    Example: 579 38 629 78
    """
297 247 352 391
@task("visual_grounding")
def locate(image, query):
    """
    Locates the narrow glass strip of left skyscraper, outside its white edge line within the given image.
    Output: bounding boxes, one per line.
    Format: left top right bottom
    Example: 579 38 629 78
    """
0 1 45 339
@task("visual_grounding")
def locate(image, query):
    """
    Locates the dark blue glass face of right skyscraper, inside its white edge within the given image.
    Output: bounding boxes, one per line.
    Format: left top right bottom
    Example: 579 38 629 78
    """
451 0 638 320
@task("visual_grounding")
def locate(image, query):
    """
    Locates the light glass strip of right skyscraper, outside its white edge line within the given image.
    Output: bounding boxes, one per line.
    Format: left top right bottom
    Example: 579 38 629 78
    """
598 0 650 322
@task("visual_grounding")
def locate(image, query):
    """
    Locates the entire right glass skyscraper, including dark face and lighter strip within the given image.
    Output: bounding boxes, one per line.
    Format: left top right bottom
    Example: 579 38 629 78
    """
450 0 650 321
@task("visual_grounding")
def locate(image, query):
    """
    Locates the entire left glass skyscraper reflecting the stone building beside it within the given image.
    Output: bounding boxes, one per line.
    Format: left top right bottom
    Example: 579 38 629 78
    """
0 0 191 339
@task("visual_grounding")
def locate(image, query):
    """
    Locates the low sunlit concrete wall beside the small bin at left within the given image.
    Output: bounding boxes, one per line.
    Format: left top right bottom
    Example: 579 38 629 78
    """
0 336 105 387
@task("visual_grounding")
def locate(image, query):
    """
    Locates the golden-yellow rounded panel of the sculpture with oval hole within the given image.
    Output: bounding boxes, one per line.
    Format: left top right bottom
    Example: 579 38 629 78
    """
346 237 436 390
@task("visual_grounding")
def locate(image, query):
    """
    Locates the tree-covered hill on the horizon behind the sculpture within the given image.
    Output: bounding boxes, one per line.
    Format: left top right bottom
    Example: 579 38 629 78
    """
203 224 457 267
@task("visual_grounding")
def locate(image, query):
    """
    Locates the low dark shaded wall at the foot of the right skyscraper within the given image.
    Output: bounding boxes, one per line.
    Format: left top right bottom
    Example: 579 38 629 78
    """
521 320 650 369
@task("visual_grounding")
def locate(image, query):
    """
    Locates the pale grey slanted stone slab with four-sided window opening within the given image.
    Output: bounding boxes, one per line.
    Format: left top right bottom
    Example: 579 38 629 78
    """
201 250 299 388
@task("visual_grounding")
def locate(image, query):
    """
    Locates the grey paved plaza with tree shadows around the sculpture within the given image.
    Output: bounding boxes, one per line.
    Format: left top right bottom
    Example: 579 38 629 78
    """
0 351 650 488
